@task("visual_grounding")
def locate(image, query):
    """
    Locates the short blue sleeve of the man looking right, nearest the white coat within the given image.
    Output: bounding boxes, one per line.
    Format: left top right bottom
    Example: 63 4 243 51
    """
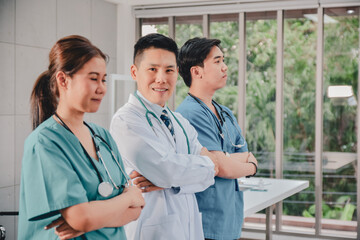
180 108 222 151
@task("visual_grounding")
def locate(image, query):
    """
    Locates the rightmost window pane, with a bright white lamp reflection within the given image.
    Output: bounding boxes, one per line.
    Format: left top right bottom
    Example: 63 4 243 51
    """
322 7 359 237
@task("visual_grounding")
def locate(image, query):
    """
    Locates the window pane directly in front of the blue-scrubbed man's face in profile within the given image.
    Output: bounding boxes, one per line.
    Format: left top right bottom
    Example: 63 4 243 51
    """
210 14 239 116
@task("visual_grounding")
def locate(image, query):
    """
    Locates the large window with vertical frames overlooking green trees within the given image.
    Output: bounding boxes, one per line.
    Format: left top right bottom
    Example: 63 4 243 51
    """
136 1 360 238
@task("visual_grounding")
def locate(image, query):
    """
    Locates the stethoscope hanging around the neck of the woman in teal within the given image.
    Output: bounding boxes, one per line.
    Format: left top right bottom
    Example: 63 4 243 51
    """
54 112 132 197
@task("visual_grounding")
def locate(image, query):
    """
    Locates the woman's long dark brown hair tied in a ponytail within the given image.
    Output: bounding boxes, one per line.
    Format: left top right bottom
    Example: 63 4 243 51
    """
30 35 108 129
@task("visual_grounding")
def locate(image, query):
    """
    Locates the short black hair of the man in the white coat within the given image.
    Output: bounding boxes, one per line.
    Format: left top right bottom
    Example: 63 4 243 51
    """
133 33 179 64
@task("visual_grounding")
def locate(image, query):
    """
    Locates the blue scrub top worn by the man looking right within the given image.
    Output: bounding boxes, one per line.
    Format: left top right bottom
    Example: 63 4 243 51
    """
176 96 248 240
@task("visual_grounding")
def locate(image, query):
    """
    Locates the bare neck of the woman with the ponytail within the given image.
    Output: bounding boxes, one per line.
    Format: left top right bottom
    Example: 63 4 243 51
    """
56 103 84 130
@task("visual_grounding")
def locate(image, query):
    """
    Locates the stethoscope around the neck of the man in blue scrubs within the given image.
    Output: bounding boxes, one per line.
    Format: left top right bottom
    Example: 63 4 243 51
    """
188 93 246 148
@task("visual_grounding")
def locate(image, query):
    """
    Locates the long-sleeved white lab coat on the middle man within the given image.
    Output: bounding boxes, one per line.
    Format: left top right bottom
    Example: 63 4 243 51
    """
110 92 215 240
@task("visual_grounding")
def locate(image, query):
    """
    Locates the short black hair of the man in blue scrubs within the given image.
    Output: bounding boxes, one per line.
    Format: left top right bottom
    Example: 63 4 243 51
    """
178 37 221 87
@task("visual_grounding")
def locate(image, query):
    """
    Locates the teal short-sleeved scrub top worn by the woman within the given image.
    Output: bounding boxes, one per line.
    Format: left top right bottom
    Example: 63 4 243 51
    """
18 117 126 240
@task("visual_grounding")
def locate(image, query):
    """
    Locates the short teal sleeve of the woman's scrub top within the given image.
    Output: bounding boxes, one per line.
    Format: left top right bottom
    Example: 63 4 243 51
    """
22 136 88 221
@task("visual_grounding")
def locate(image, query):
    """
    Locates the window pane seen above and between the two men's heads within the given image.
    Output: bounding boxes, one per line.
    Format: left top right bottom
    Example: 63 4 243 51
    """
175 16 203 109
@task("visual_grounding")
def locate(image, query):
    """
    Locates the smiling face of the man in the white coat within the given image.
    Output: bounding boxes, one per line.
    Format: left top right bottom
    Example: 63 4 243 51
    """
131 48 178 107
